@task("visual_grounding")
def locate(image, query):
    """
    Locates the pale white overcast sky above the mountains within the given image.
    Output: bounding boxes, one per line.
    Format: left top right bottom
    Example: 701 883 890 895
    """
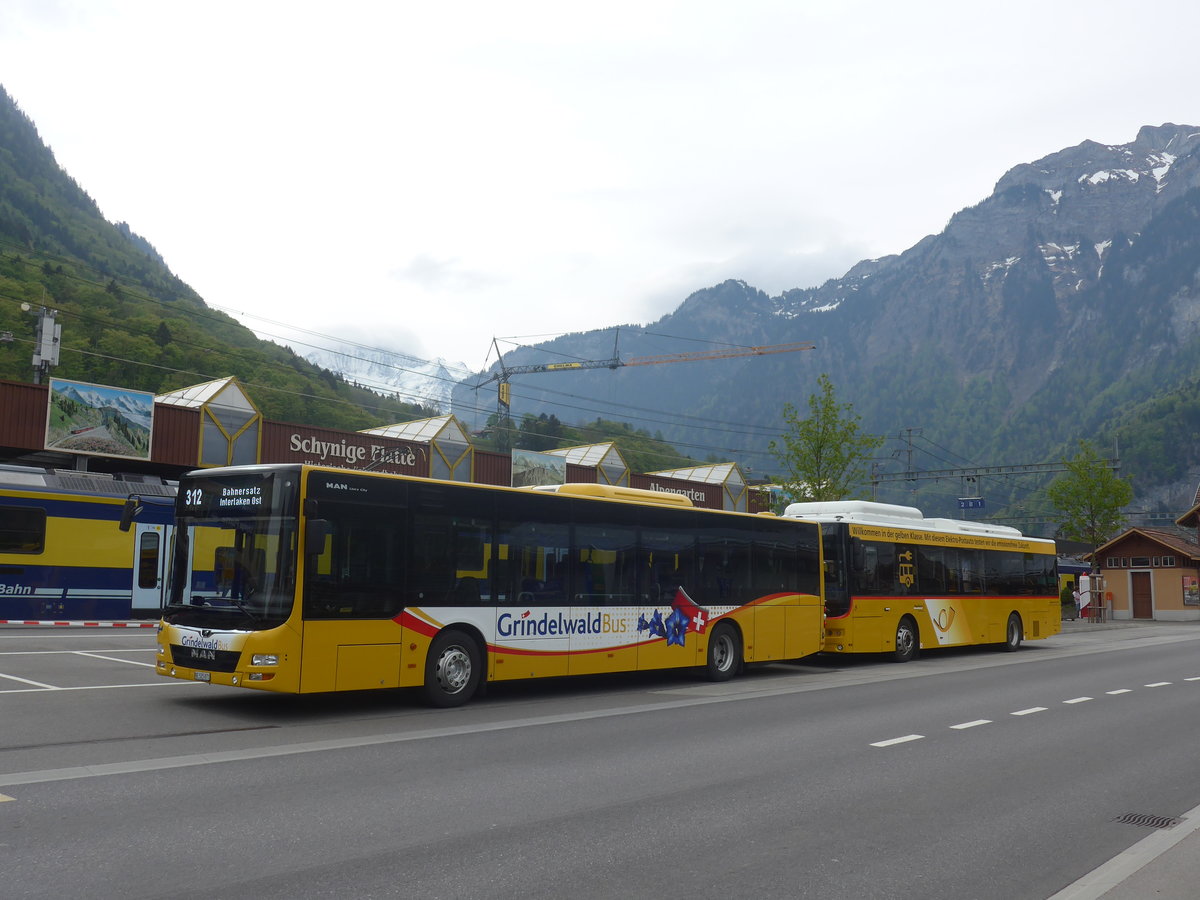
0 0 1200 367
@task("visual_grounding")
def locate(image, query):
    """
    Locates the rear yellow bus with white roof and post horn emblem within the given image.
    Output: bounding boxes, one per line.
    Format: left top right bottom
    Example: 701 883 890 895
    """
784 500 1062 662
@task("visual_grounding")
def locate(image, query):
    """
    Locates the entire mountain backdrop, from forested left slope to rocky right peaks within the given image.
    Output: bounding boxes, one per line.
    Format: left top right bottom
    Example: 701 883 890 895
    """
0 77 1200 528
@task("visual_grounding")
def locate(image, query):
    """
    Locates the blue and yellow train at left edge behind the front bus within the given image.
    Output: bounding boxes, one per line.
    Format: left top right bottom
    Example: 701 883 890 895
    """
0 466 175 622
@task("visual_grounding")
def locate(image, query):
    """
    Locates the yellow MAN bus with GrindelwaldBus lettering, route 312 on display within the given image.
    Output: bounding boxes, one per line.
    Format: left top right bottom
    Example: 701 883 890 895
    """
150 464 823 707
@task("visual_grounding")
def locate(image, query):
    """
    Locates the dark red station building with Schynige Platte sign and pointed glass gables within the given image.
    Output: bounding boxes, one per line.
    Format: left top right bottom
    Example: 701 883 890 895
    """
0 377 769 512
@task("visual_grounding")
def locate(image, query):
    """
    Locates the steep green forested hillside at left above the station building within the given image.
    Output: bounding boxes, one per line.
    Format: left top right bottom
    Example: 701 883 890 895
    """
0 88 427 430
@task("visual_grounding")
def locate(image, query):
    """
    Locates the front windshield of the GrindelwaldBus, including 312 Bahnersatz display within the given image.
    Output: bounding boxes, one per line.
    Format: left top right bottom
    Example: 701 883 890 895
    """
164 470 298 631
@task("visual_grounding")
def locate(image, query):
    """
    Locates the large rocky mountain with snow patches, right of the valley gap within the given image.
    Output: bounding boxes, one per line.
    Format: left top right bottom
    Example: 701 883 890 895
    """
455 124 1200 525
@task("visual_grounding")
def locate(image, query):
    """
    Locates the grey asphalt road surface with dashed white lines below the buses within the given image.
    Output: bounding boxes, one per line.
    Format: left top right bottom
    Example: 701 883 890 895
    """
0 625 1200 900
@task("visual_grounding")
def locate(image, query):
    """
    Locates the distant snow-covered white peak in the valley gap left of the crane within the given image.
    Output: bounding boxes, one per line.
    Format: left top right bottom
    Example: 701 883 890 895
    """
305 344 472 413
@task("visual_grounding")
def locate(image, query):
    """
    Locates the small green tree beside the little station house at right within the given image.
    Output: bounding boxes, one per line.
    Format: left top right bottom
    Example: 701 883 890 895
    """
1046 440 1133 550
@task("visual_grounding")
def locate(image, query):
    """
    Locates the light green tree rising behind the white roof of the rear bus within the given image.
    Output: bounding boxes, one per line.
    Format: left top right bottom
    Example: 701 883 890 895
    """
768 373 883 500
